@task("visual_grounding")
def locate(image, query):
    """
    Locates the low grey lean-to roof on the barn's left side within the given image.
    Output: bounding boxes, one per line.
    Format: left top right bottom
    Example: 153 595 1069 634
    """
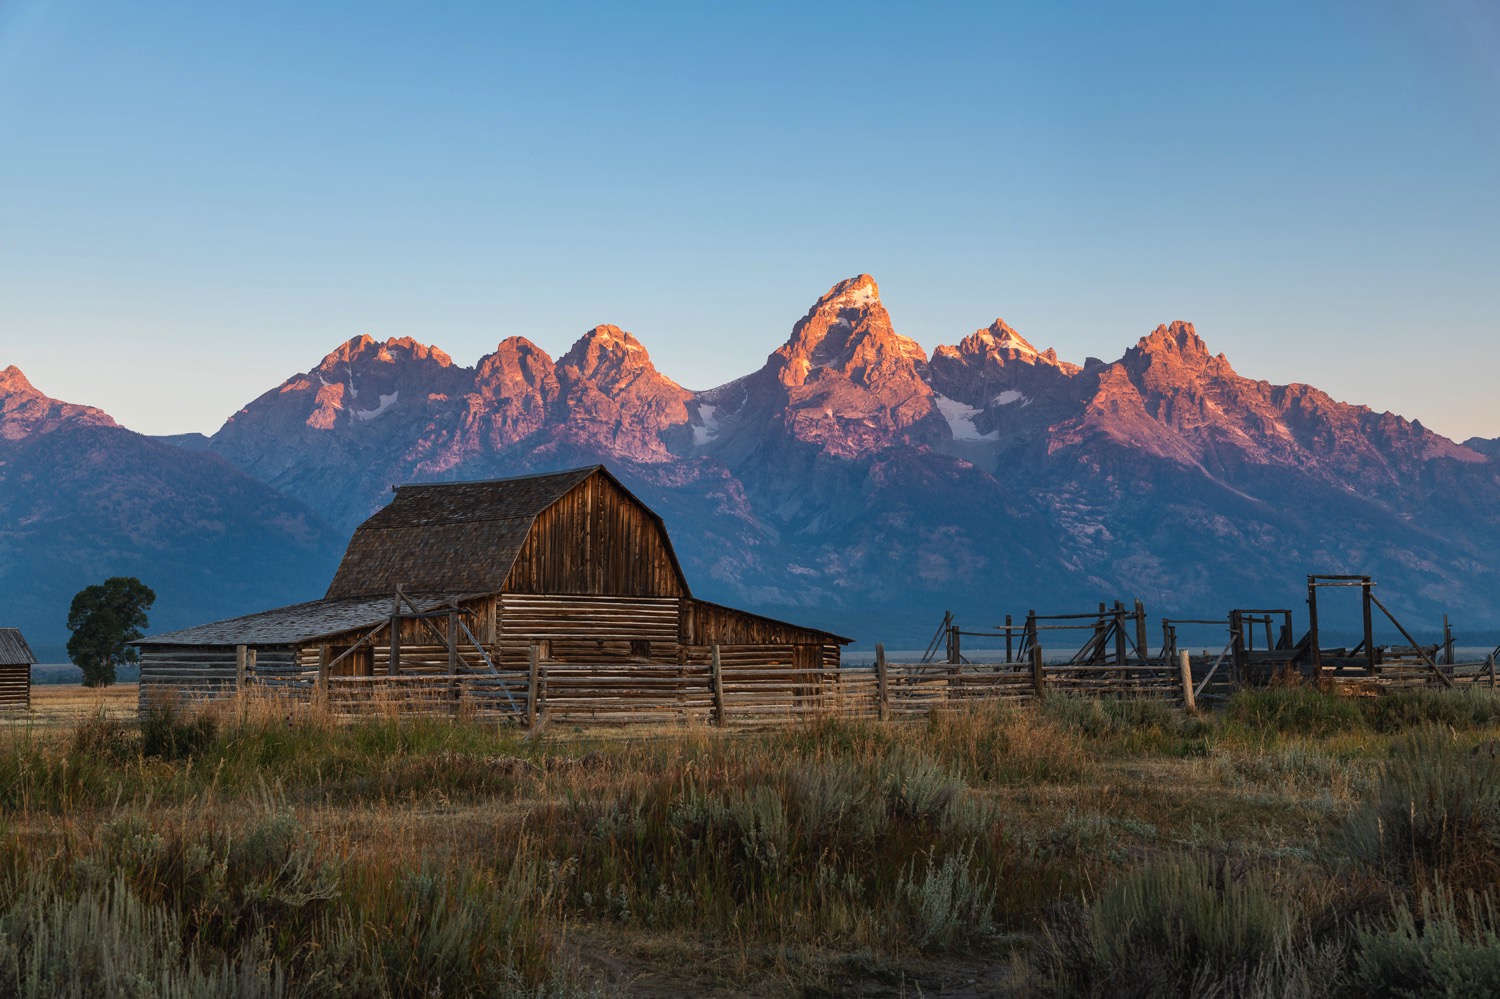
137 593 470 645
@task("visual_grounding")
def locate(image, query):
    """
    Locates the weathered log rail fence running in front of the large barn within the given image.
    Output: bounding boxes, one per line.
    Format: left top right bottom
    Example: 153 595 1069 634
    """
240 647 1191 729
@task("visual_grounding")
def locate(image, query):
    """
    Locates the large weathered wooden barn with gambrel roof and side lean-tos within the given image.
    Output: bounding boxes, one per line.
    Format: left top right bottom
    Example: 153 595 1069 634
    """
140 465 849 708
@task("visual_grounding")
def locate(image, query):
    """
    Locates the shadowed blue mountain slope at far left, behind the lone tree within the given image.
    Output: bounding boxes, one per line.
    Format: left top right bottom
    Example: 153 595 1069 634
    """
0 368 342 662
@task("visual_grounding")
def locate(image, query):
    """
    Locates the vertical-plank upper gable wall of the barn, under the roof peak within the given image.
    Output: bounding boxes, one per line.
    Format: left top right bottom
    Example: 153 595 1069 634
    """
506 476 686 597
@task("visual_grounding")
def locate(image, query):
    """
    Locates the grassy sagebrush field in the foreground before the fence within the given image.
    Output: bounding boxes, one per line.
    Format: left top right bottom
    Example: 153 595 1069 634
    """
0 687 1500 998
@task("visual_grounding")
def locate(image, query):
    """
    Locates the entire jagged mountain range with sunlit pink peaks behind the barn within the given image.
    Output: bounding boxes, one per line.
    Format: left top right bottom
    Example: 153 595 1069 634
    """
0 275 1500 656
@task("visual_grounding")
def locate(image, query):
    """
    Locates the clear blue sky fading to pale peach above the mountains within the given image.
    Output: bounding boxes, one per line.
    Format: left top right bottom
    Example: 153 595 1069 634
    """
0 0 1500 440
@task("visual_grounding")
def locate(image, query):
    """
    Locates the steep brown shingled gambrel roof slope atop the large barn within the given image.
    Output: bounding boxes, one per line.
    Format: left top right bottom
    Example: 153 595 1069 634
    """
327 465 618 600
